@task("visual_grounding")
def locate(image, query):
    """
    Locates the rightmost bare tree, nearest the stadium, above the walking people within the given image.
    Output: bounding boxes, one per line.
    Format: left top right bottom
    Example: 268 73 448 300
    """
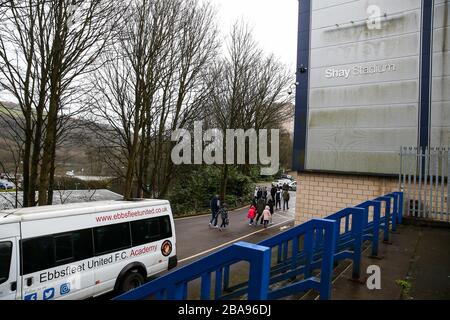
209 22 293 199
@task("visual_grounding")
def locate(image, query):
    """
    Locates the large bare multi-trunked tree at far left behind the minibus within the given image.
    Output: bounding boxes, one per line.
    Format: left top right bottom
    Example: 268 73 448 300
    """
0 0 126 206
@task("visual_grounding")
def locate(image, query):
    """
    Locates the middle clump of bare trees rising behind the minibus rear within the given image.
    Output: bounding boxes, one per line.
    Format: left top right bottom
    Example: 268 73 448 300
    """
92 0 218 199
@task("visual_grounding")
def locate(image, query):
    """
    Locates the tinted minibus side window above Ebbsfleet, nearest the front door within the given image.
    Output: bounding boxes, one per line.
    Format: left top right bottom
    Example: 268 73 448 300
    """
22 236 55 275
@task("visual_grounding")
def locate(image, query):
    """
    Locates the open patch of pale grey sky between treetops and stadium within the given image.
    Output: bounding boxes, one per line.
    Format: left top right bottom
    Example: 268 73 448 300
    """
210 0 298 70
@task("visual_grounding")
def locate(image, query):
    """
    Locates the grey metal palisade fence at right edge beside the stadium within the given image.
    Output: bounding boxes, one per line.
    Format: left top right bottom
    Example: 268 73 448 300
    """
399 147 450 222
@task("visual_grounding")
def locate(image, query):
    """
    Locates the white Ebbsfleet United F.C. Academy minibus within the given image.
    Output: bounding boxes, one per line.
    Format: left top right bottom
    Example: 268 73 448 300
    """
0 200 177 300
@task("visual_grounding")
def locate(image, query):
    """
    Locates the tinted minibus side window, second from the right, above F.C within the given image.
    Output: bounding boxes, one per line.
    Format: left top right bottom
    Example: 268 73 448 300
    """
94 222 131 256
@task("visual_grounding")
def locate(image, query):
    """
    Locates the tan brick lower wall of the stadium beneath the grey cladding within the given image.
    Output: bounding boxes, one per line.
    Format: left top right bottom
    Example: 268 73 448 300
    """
296 173 398 224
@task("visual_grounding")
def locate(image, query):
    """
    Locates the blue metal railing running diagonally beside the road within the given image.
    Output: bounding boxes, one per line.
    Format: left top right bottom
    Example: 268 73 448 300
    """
115 192 404 300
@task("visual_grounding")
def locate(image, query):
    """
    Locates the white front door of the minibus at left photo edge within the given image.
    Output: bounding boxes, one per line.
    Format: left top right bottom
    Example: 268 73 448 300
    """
0 238 22 300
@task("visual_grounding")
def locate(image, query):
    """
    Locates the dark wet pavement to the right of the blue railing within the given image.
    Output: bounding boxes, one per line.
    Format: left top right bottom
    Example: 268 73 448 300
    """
326 225 450 300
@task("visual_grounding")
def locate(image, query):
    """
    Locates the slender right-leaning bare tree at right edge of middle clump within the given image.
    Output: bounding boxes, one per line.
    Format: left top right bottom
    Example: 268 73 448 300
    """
150 0 219 197
